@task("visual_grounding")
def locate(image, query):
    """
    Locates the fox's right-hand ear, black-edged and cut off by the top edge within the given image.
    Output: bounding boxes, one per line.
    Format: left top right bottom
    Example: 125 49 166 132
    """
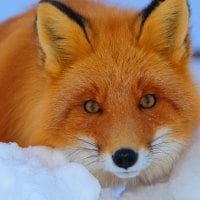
139 0 191 62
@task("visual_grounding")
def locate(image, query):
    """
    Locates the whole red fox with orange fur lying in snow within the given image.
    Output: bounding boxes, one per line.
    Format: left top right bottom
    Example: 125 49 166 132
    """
0 0 199 183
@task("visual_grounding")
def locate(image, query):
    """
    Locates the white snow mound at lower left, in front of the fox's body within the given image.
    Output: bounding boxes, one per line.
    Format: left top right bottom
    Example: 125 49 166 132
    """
0 143 101 200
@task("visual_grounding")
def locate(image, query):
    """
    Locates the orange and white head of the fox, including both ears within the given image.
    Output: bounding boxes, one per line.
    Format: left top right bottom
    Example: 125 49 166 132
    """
32 0 197 182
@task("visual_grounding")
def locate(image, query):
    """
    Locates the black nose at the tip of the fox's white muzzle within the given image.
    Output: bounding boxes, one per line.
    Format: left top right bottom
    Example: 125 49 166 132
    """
112 149 138 169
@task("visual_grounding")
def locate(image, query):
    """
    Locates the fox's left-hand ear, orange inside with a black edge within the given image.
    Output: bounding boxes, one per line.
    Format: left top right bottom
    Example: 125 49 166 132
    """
36 0 91 76
